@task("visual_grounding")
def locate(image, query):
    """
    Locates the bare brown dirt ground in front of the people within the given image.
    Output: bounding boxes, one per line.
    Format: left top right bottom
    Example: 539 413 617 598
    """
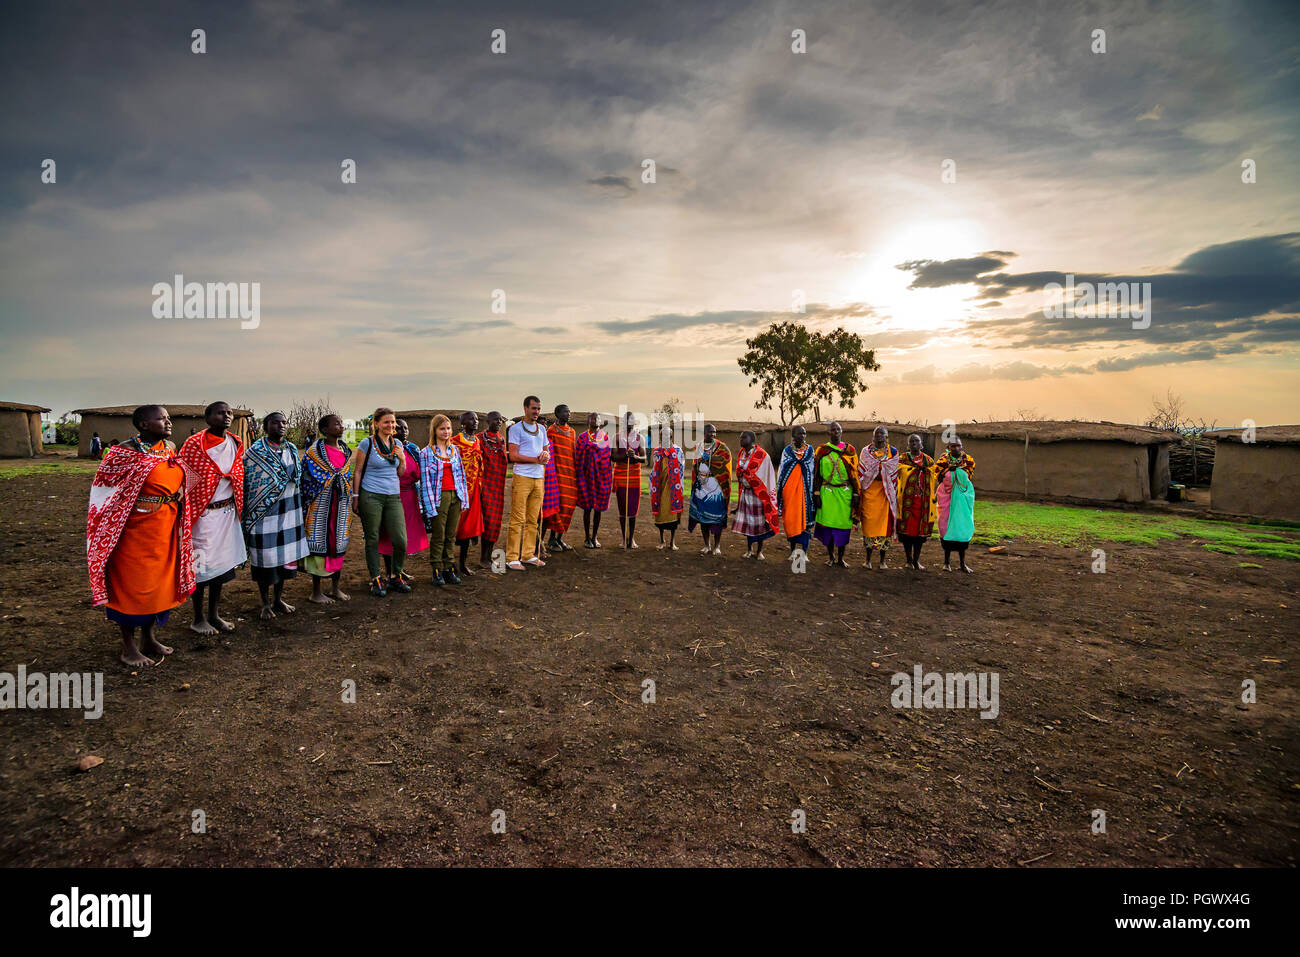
0 462 1300 866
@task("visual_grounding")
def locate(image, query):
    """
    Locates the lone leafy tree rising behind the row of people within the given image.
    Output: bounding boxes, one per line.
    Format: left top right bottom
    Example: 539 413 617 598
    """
736 322 880 428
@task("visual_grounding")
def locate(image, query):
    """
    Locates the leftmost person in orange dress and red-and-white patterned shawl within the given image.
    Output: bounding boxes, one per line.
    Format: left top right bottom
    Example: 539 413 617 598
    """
86 406 194 667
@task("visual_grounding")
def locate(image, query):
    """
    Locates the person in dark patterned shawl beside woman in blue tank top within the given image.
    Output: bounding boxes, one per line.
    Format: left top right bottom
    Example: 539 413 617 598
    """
303 413 352 605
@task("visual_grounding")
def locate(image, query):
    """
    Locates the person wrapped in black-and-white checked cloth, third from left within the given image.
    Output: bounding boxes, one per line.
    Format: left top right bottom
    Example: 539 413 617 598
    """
243 412 312 620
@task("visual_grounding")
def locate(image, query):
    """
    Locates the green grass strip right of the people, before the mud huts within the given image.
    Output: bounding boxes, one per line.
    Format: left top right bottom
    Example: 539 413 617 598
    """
975 501 1300 562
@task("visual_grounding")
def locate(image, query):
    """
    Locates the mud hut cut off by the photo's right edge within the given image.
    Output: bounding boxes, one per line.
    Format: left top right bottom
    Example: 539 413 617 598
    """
1205 425 1300 521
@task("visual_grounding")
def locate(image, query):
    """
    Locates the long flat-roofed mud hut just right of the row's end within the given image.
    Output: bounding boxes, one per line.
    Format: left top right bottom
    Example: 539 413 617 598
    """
930 421 1180 502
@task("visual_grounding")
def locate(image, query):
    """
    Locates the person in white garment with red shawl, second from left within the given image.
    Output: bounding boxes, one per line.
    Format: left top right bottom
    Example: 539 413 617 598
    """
177 402 248 635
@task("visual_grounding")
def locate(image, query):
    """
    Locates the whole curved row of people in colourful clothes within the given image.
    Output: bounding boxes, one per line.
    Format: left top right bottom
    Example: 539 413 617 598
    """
87 395 975 664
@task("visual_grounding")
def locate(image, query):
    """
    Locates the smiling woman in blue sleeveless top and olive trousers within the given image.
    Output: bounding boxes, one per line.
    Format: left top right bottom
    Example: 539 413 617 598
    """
348 407 415 598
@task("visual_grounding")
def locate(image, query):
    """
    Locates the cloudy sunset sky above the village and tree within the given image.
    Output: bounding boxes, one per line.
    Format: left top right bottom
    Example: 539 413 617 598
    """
0 0 1300 426
